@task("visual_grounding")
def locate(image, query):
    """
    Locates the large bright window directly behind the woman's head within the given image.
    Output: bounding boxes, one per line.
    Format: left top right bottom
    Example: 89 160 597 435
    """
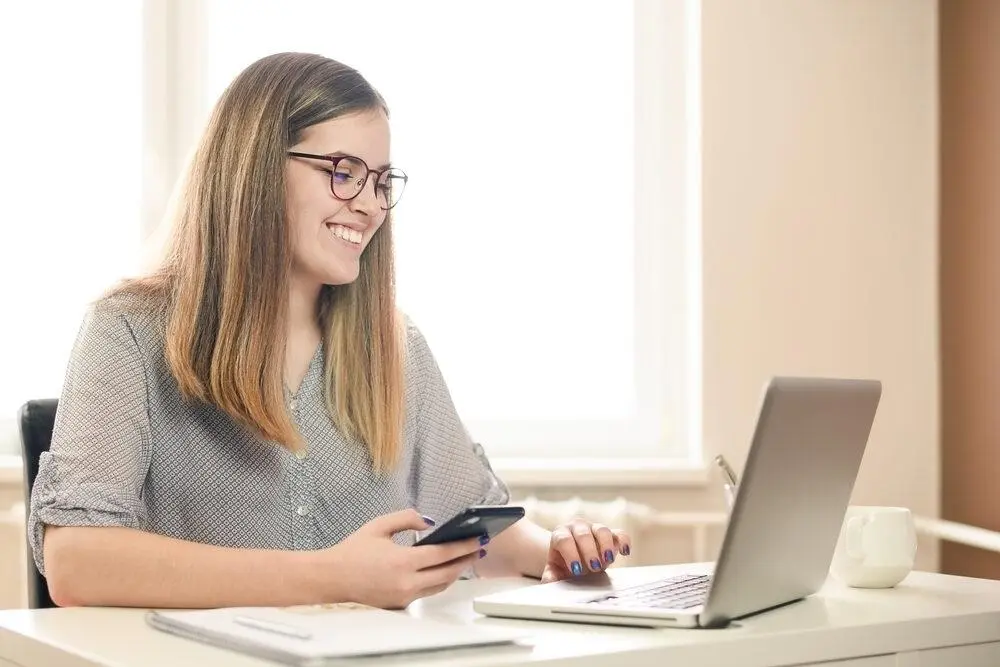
0 0 700 470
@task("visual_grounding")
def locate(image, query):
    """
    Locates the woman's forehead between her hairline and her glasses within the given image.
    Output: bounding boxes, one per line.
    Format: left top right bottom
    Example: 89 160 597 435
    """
299 110 389 167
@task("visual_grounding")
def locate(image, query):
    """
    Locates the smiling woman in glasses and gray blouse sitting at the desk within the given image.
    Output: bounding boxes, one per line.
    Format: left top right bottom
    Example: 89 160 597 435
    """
29 53 629 608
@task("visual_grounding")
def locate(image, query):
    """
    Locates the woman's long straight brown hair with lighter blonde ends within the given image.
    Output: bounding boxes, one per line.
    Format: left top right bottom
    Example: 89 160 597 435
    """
115 53 405 471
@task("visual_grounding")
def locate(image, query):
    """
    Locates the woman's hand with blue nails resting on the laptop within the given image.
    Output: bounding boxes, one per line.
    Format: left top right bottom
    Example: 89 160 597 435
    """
542 519 632 583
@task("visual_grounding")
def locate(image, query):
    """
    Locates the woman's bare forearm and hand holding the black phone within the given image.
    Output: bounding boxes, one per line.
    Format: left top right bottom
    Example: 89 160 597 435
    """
45 509 480 609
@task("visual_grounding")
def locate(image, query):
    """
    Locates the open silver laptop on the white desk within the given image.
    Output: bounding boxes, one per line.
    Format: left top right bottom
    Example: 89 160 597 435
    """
473 377 882 628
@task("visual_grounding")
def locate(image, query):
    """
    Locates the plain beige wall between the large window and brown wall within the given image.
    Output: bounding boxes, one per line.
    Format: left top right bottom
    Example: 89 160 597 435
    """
512 0 939 568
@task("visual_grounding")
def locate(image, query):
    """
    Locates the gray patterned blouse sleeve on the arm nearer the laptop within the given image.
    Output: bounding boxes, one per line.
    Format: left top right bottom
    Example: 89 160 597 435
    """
407 323 510 521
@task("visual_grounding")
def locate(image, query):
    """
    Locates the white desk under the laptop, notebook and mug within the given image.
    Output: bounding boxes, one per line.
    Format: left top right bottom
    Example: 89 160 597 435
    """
0 566 1000 667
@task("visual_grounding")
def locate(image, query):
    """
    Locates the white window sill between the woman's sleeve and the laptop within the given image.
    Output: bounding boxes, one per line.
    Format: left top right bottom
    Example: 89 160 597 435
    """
491 457 709 488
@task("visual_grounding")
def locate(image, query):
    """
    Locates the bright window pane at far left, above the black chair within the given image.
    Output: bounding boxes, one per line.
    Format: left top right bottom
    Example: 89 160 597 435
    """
0 1 143 453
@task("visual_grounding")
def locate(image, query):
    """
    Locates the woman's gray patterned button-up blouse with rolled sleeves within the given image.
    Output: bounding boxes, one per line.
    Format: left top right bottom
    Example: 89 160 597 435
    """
28 298 509 573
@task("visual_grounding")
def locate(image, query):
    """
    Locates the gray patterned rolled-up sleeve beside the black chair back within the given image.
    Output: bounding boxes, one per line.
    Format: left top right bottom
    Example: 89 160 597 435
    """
28 304 150 573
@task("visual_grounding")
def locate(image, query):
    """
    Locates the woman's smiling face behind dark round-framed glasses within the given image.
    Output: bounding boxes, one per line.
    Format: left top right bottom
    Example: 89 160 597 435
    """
285 110 389 289
